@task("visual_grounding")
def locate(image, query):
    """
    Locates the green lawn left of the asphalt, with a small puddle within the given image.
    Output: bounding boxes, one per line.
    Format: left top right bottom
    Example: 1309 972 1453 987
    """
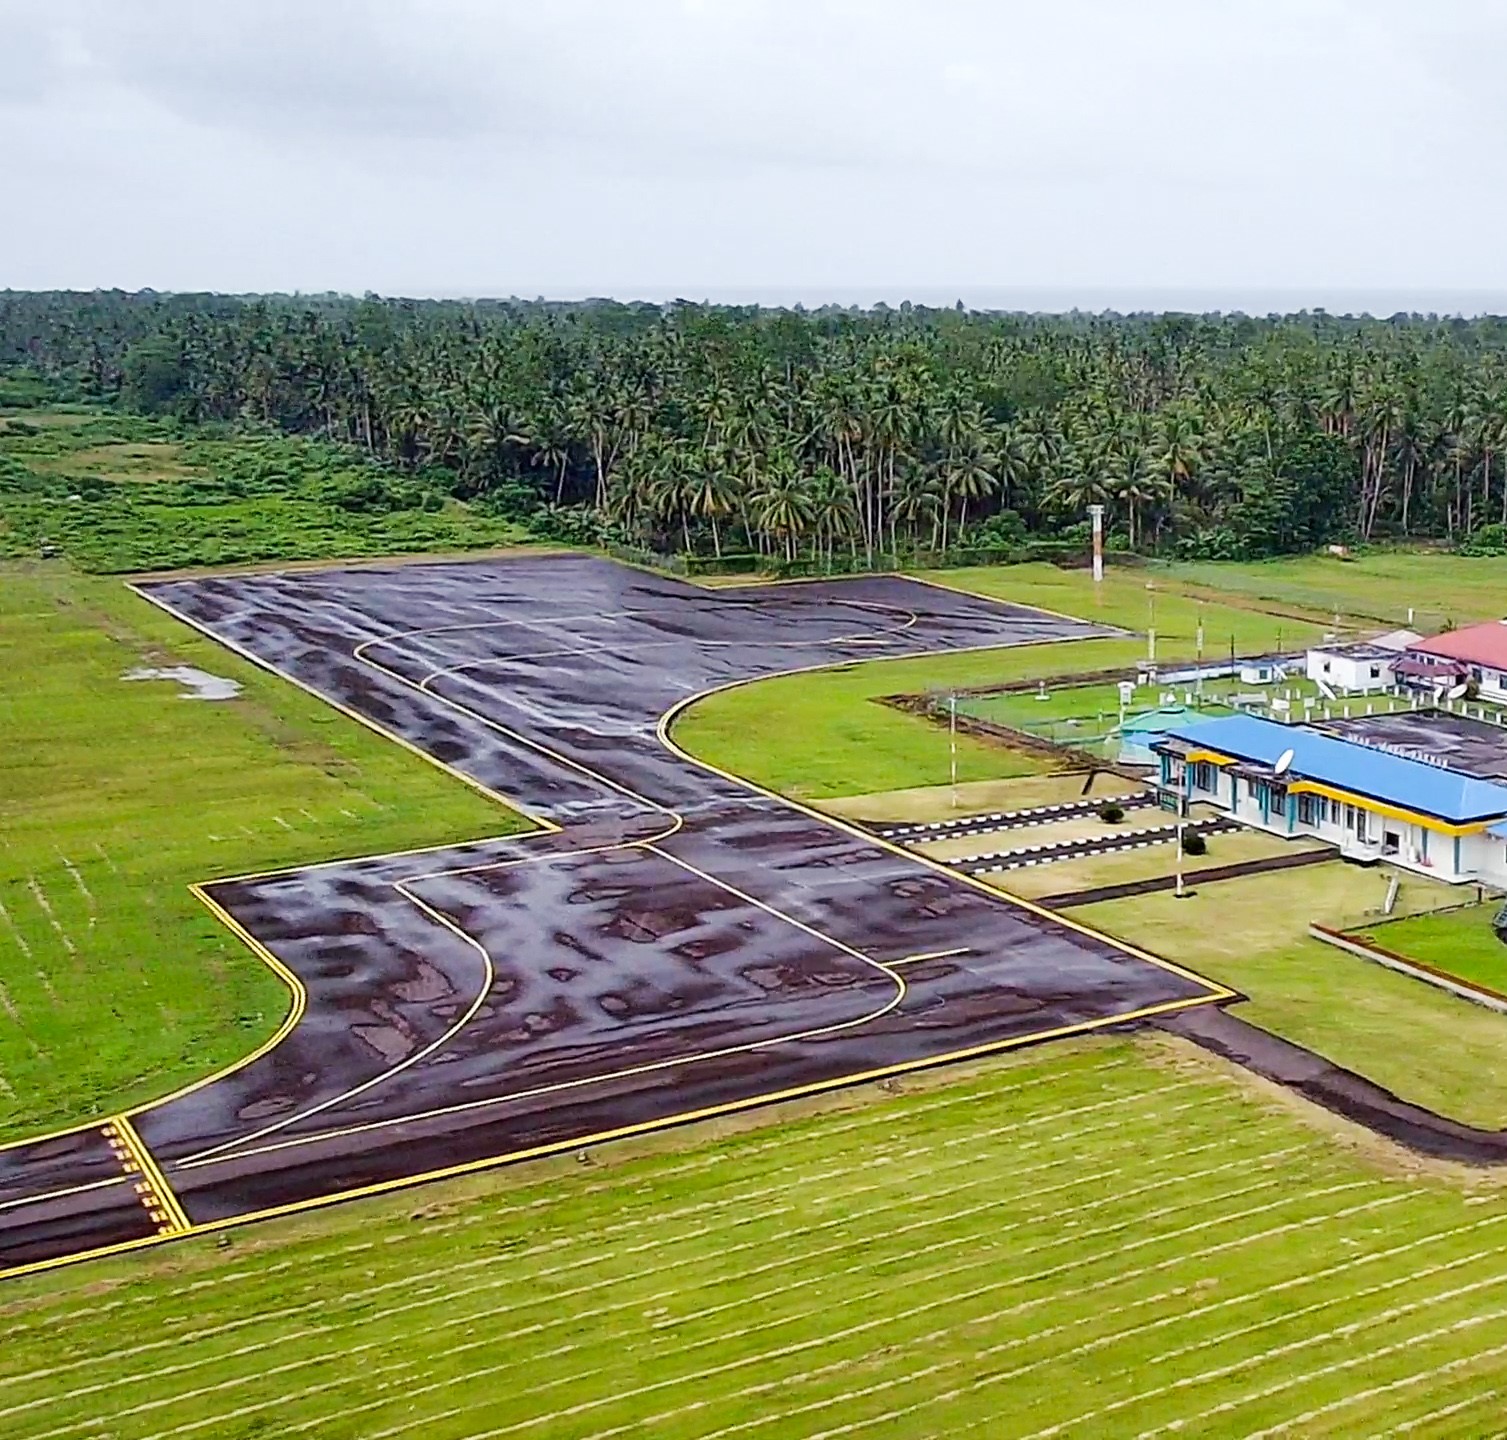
0 563 523 1137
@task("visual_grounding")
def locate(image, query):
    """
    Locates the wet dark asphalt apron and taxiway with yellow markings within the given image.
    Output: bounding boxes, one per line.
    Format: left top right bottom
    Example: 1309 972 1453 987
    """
0 556 1215 1268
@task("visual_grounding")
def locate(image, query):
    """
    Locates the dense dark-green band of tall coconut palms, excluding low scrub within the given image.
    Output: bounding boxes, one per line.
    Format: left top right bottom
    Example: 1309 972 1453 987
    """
0 292 1507 565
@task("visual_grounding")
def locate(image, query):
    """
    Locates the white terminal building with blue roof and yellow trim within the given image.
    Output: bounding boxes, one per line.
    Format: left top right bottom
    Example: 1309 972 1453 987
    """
1151 715 1507 887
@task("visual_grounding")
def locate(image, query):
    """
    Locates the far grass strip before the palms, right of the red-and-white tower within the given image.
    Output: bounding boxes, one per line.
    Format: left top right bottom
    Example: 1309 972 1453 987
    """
1154 550 1507 634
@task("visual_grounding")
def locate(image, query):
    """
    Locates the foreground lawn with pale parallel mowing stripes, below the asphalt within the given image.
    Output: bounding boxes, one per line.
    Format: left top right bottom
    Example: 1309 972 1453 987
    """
0 1039 1507 1440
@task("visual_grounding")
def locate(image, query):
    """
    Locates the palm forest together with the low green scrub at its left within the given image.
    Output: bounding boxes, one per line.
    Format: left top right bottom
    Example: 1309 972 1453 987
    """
0 291 1507 574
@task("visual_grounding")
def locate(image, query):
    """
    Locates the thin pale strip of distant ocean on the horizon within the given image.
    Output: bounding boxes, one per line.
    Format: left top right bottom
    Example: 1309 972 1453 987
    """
440 285 1507 318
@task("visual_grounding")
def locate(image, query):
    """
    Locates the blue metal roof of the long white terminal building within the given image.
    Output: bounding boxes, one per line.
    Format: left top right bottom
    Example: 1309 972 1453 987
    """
1153 715 1507 825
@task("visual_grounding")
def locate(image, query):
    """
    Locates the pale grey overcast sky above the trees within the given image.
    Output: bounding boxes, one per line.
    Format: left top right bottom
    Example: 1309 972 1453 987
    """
0 0 1507 309
